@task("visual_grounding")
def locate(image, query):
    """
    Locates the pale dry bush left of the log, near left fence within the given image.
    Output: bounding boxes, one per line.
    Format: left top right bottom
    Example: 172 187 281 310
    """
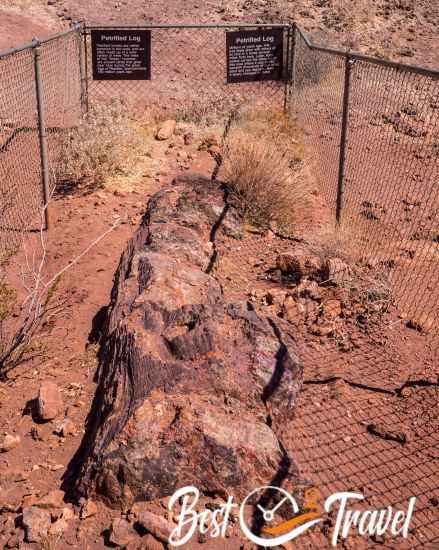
57 99 145 191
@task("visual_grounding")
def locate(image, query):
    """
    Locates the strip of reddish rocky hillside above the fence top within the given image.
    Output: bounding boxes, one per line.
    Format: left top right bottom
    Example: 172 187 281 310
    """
0 0 439 67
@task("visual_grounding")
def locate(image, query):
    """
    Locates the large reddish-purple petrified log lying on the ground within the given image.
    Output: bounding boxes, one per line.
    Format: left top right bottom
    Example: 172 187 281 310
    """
76 176 302 507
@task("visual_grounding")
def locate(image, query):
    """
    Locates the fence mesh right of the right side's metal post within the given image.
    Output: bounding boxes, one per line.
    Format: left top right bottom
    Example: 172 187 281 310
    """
342 60 439 331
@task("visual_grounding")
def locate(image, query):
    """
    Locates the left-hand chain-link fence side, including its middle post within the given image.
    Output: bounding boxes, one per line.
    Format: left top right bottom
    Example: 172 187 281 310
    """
0 26 81 259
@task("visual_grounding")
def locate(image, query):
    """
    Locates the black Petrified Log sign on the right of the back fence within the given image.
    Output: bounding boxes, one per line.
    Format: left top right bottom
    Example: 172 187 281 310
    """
226 29 284 83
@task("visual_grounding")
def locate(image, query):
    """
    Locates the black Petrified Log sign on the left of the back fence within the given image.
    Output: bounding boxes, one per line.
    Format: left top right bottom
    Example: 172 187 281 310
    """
91 29 151 80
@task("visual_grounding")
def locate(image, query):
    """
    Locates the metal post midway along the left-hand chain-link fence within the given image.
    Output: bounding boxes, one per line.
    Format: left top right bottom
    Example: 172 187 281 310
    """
33 39 50 229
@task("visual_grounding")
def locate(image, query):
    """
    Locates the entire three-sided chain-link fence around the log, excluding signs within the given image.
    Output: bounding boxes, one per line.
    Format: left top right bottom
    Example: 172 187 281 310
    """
0 21 439 324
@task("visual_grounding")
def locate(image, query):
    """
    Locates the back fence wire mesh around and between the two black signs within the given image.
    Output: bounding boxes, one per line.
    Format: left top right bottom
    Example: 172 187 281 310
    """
87 26 288 119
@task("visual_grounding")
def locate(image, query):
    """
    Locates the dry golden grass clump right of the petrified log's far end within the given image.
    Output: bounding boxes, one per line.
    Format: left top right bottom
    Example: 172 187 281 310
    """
222 110 309 232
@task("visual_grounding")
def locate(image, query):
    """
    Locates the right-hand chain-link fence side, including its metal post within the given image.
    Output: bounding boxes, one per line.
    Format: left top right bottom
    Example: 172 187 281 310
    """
290 23 439 333
